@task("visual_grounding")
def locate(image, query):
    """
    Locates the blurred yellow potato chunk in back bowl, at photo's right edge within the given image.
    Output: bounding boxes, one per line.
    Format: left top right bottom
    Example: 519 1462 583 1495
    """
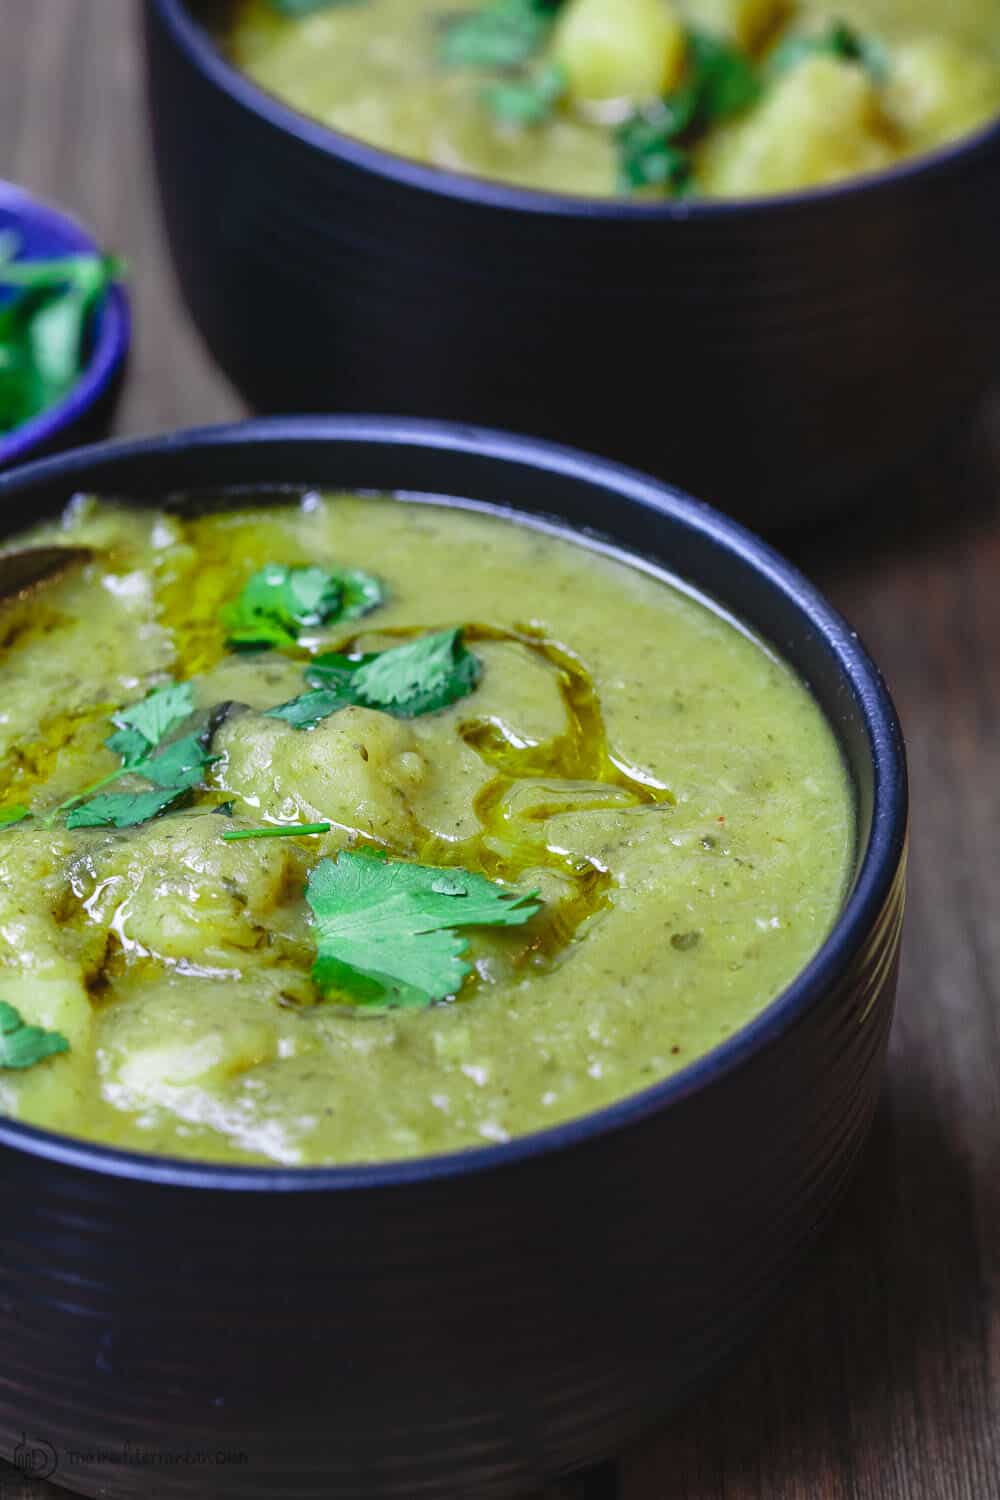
886 36 1000 150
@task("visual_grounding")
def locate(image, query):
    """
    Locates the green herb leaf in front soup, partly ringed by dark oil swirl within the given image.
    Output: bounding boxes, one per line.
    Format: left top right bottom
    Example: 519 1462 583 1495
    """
267 627 483 729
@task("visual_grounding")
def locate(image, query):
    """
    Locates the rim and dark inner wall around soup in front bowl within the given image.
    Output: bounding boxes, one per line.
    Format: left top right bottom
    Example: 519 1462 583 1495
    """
0 417 907 1187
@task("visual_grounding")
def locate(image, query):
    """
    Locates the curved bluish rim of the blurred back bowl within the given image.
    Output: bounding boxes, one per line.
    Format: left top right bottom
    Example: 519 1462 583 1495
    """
145 0 1000 224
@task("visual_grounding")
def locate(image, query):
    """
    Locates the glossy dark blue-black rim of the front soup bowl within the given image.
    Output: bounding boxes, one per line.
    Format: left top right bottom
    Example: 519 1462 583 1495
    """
0 416 909 1193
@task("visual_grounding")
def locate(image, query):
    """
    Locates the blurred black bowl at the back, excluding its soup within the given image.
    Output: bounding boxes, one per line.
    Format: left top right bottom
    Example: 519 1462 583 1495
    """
145 0 1000 525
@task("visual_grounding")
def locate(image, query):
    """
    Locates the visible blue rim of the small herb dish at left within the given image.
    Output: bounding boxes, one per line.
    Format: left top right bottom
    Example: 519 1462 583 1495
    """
0 183 130 468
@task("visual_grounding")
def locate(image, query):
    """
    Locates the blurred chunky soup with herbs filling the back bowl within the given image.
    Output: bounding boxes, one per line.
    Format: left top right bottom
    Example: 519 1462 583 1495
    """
225 0 1000 198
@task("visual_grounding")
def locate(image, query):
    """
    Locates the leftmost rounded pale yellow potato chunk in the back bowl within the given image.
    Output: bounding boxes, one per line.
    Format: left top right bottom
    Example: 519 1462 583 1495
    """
553 0 685 104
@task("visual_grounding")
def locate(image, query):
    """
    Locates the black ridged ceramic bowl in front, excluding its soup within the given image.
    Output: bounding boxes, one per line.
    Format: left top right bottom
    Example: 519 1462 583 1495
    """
0 419 907 1500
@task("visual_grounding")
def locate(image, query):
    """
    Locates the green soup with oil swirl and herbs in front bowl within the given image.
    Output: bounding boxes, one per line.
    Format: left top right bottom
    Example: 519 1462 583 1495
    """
0 494 855 1166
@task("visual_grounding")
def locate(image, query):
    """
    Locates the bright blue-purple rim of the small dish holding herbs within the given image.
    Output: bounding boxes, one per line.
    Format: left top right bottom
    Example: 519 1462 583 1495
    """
0 182 132 467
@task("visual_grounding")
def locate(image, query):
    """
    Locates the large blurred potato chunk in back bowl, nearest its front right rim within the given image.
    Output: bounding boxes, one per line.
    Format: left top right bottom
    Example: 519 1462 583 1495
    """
697 56 898 198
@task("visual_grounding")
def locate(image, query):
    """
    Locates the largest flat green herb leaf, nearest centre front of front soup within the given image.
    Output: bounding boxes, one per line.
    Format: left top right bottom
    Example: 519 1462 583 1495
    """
306 852 540 1008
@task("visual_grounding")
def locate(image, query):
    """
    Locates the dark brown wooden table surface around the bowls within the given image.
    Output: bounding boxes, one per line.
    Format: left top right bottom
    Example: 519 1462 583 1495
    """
0 0 1000 1500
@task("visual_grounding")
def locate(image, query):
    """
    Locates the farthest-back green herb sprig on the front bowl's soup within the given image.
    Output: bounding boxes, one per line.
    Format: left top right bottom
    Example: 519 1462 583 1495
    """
222 563 385 651
